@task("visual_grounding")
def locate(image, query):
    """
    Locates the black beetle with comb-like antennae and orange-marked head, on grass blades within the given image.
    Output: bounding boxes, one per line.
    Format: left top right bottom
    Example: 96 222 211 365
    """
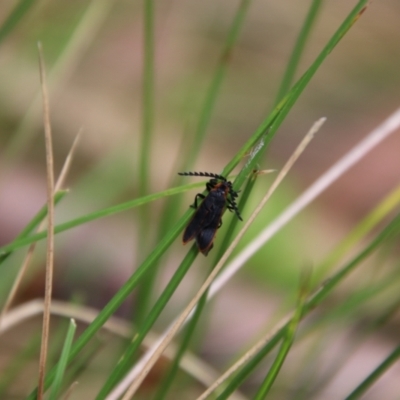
178 172 243 256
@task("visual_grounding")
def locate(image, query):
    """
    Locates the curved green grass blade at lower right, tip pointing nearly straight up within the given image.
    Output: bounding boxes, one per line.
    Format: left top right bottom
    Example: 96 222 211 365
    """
254 271 311 400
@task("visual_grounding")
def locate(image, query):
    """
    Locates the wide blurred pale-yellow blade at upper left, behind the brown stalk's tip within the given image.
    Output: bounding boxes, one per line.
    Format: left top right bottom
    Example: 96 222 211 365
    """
0 0 114 172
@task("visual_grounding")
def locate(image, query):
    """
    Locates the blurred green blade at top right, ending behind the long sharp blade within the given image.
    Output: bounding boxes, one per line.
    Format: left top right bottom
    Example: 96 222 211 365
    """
275 0 322 104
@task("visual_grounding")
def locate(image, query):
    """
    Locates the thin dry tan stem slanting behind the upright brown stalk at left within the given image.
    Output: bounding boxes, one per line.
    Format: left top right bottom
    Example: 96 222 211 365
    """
0 132 81 326
